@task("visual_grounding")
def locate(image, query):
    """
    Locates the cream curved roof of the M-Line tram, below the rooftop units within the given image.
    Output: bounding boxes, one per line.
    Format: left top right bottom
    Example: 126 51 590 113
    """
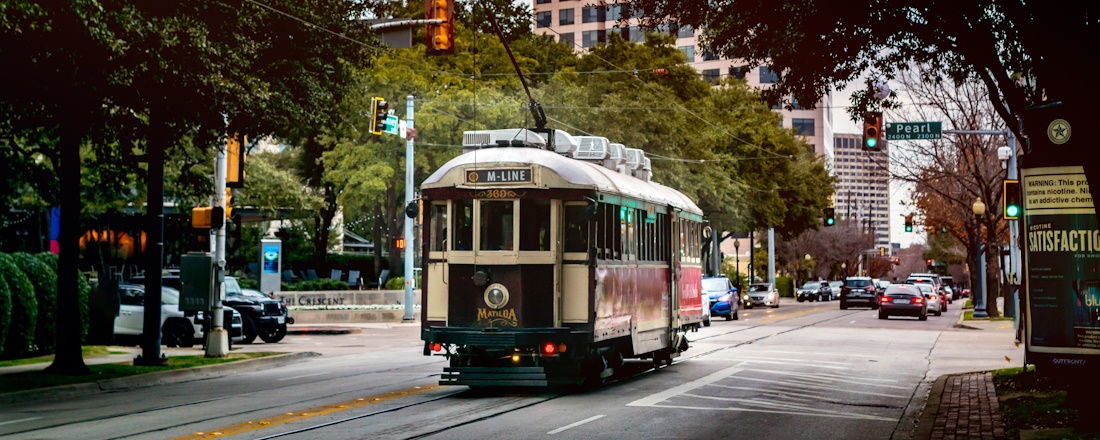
421 147 703 216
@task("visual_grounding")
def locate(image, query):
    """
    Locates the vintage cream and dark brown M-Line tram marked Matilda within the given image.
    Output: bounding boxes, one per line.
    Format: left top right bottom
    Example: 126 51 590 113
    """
420 129 704 386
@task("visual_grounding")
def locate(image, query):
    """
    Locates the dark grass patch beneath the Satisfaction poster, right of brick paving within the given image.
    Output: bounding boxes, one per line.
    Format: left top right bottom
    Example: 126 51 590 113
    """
993 367 1100 439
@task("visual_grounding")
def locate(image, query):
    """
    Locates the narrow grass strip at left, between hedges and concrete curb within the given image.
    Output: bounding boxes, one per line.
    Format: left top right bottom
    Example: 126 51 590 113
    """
0 349 283 392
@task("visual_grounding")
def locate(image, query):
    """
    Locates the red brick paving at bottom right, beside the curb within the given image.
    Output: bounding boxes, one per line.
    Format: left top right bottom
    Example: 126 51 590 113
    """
932 373 1008 440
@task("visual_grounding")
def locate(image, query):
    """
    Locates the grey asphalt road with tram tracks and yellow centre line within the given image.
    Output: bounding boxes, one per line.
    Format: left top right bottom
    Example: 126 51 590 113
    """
0 294 1019 439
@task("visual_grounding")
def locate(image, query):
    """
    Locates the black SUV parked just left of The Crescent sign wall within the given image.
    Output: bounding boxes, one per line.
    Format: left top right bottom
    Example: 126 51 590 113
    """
222 276 292 343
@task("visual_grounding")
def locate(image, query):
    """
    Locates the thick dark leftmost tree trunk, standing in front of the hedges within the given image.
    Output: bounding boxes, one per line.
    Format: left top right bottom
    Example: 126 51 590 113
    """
46 122 89 375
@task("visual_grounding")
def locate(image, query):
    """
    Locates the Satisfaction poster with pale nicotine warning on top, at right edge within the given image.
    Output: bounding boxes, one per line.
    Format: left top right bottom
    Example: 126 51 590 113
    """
1021 166 1100 354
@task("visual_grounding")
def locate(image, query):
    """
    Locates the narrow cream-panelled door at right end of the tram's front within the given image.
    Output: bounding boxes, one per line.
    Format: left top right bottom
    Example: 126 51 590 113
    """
560 201 592 327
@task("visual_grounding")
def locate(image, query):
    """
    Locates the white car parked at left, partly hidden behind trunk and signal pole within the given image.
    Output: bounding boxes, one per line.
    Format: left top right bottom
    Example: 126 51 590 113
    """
114 284 243 347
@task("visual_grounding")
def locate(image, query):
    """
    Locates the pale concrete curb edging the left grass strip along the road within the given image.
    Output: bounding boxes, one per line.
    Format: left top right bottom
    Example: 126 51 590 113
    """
0 352 321 405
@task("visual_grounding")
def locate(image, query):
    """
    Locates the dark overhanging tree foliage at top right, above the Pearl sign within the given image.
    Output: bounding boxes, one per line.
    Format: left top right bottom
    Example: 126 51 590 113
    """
624 0 1100 139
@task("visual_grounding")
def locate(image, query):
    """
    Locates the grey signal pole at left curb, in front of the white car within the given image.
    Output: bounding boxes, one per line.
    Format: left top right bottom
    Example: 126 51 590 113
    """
206 139 229 358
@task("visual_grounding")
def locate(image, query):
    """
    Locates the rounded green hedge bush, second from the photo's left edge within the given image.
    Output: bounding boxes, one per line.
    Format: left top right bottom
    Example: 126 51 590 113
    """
0 254 39 358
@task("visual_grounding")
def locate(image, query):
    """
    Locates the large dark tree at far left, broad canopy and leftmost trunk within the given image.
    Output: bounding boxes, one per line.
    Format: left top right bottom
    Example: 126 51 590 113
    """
0 0 366 373
